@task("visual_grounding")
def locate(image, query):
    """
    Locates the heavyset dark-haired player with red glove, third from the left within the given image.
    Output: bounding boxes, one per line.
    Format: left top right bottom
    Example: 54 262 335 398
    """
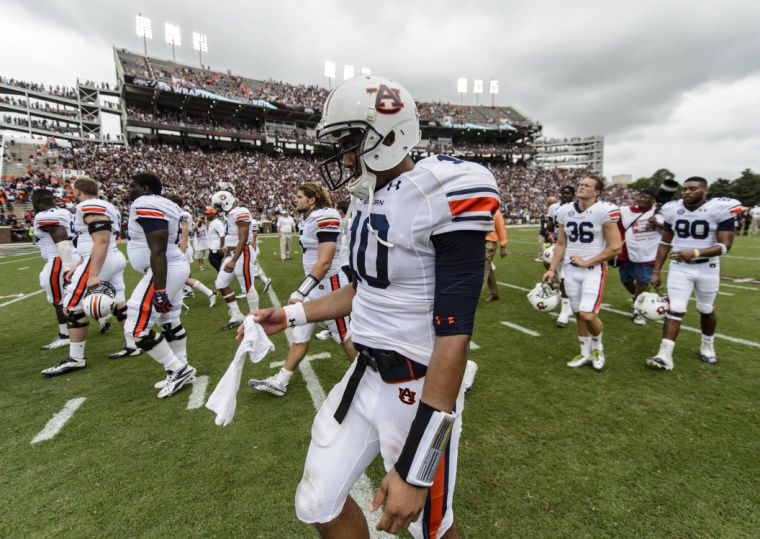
126 174 195 399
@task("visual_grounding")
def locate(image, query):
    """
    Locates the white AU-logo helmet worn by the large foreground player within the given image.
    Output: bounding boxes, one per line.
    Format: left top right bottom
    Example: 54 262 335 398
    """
317 75 421 200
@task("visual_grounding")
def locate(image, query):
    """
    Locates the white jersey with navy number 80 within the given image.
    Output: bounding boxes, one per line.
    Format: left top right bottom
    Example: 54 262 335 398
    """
662 197 742 251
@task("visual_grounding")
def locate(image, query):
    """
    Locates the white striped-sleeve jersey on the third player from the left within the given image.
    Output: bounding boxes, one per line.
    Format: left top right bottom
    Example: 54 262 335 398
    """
127 195 185 273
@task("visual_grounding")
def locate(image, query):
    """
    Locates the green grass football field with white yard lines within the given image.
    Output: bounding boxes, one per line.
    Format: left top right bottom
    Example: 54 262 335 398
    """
0 228 760 538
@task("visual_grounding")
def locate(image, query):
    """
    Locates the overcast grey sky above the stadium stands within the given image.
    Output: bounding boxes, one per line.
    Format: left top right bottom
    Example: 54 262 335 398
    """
0 0 760 181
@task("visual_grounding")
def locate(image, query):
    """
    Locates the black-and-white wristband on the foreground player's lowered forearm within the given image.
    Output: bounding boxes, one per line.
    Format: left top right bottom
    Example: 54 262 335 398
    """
394 401 456 487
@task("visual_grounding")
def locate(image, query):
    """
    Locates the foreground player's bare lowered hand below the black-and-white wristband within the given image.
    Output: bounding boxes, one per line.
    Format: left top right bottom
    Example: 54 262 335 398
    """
369 468 428 534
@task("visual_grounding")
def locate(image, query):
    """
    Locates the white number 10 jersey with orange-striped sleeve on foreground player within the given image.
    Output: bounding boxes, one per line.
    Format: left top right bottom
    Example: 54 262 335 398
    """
349 155 499 365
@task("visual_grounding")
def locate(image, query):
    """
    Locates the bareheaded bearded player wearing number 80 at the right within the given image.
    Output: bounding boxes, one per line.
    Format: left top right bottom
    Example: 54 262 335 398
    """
646 176 742 371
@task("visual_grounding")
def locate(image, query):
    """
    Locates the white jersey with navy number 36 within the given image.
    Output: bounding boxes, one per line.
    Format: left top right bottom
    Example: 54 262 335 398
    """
557 200 620 263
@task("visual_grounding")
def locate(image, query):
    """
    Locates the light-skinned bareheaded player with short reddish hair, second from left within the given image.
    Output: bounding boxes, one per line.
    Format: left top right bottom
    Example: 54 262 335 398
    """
42 178 141 377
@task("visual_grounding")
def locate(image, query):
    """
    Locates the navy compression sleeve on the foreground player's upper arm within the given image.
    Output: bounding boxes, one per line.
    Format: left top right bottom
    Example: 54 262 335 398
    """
432 230 486 336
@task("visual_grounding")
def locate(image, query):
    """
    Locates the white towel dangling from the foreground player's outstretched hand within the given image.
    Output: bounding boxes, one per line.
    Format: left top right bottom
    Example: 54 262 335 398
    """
206 315 274 427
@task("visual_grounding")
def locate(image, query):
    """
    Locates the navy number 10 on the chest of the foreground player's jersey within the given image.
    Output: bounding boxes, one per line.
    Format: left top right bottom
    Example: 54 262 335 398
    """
348 211 391 288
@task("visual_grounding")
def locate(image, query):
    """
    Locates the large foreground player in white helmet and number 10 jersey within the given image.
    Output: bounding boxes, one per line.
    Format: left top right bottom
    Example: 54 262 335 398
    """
239 76 499 537
